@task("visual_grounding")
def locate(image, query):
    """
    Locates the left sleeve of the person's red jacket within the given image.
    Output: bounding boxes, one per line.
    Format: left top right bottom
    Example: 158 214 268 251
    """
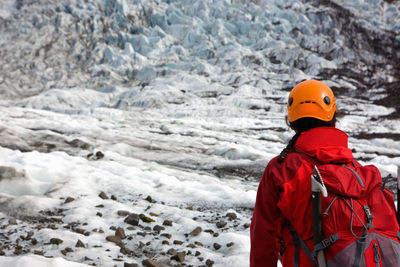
250 166 281 267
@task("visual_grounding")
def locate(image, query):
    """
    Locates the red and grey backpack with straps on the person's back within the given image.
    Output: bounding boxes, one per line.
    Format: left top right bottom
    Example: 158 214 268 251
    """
289 161 400 267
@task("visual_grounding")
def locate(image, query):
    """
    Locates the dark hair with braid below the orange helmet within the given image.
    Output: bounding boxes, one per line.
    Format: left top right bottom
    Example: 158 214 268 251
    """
278 114 336 163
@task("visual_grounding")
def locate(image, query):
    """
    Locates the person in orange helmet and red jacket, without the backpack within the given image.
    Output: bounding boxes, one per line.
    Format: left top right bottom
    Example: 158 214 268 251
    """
250 80 397 267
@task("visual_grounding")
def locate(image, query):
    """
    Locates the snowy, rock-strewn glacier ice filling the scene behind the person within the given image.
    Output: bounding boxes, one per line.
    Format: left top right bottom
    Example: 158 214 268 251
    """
0 0 400 267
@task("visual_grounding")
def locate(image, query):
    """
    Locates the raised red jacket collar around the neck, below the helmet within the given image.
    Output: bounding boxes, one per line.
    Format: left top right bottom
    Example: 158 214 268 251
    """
294 127 353 163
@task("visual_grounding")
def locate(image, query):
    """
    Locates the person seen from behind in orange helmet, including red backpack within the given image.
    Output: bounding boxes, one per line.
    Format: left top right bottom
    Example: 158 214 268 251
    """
250 80 400 267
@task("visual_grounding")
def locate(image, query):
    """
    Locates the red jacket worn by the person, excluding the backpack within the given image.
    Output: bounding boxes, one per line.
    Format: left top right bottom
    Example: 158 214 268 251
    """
250 127 358 267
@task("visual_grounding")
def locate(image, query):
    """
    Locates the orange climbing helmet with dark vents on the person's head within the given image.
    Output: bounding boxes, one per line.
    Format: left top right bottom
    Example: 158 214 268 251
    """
287 80 336 122
